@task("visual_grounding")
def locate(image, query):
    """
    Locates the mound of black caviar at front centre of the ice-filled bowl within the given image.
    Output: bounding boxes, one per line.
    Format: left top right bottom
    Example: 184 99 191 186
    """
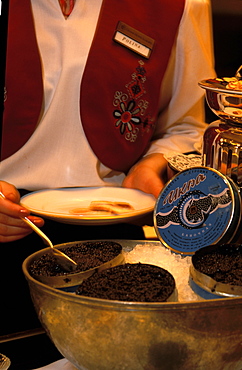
76 263 175 302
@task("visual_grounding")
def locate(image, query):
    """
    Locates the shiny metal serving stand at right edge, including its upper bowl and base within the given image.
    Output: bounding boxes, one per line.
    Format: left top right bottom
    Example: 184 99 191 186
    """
199 74 242 187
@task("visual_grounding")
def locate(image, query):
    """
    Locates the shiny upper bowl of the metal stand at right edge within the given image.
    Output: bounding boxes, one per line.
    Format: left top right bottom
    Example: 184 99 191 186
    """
199 79 242 125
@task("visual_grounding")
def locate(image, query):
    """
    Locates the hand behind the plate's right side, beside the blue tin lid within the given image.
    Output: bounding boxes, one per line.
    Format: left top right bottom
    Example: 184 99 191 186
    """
122 153 170 198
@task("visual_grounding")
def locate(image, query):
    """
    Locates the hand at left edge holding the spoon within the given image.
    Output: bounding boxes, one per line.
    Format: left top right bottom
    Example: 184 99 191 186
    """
0 181 44 243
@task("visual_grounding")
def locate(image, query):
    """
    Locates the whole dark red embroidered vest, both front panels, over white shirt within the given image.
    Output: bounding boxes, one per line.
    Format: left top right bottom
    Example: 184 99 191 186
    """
2 0 185 171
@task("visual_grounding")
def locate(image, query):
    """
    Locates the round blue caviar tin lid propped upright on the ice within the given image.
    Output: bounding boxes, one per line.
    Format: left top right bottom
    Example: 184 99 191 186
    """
154 166 241 255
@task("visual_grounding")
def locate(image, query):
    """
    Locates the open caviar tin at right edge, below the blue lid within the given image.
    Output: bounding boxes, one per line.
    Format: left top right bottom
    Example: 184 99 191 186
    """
189 244 242 299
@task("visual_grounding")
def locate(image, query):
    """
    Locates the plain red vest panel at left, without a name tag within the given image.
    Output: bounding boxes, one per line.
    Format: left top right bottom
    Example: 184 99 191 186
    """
2 0 43 159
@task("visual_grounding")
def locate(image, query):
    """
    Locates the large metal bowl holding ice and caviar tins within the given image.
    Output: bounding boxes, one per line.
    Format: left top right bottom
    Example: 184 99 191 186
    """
23 240 242 370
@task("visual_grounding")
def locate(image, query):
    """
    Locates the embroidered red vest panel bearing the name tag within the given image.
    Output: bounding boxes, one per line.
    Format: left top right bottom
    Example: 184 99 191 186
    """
80 0 184 172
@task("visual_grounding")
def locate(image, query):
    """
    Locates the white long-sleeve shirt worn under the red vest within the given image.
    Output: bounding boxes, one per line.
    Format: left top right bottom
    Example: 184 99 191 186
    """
0 0 214 190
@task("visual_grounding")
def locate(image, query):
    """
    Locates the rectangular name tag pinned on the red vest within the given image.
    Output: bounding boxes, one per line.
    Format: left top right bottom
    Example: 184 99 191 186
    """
114 22 155 59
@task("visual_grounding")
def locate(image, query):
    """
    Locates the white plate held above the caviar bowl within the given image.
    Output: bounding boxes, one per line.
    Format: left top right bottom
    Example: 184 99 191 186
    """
21 186 156 225
